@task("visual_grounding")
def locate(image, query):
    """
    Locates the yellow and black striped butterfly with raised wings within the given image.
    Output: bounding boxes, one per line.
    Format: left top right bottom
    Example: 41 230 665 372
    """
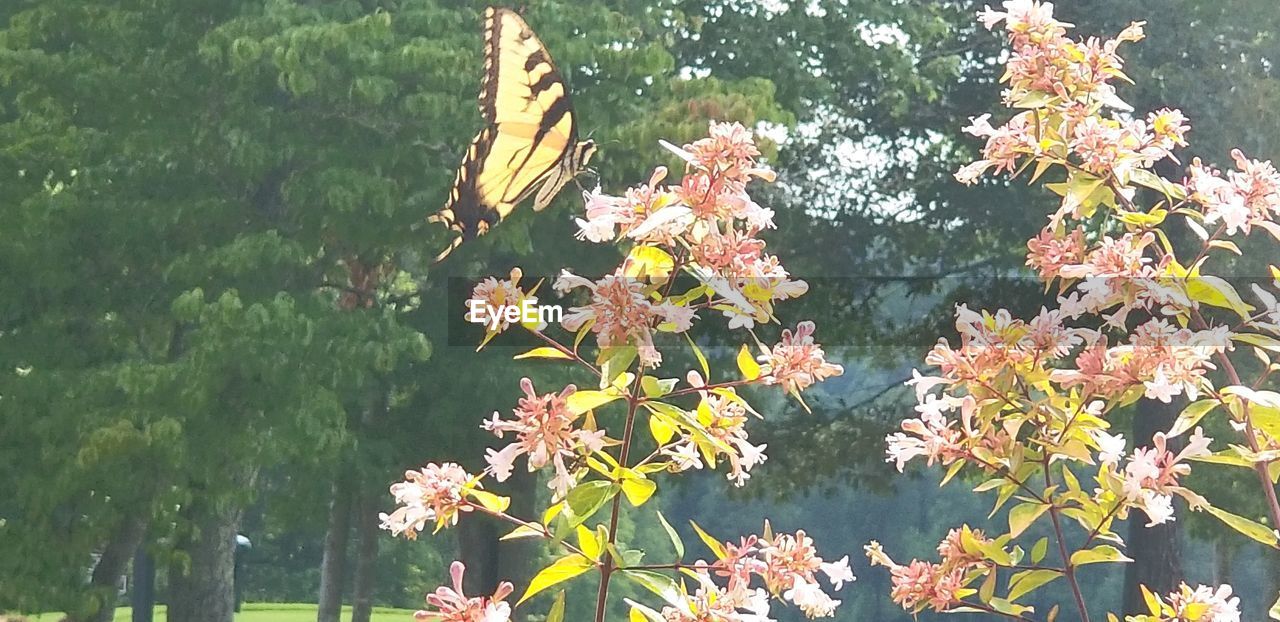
428 6 595 261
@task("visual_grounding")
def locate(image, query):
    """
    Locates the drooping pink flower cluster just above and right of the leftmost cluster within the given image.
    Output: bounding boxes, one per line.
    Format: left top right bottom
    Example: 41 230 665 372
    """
484 378 604 494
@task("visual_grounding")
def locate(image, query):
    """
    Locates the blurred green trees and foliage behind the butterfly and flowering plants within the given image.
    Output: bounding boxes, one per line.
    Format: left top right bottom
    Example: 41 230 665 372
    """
0 0 1280 622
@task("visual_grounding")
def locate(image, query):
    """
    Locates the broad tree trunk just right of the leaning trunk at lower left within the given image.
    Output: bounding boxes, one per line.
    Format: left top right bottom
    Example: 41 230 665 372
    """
168 466 257 622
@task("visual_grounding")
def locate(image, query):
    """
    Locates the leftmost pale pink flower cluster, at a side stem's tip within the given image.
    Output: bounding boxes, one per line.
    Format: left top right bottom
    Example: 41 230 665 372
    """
378 462 472 540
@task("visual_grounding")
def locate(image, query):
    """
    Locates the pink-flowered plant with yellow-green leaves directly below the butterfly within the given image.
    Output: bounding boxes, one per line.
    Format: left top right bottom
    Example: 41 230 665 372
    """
381 123 854 622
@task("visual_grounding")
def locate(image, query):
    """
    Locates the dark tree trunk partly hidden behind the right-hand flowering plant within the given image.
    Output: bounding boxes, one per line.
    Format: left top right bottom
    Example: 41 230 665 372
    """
1124 399 1183 614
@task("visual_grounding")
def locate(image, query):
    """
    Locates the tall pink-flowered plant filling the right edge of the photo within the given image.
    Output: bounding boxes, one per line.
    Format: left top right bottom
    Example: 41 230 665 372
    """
867 0 1280 622
